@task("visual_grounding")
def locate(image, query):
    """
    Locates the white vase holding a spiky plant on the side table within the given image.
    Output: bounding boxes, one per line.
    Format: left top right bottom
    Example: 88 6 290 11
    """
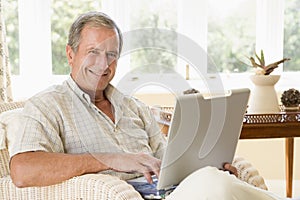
244 50 290 114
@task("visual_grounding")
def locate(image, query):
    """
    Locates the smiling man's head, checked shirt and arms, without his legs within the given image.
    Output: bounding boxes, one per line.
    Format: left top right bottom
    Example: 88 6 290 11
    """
10 12 236 187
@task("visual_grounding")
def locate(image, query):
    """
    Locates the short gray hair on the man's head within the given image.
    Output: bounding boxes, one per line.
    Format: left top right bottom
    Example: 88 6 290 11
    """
68 11 123 54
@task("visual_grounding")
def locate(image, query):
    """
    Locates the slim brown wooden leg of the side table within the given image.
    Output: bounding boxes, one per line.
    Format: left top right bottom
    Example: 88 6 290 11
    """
285 137 294 197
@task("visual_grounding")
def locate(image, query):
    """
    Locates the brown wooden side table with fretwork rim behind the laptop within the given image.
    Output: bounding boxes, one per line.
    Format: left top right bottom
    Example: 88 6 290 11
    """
158 107 300 197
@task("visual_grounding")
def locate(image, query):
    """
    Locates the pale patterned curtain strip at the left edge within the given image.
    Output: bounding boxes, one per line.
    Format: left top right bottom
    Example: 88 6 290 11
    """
0 0 13 103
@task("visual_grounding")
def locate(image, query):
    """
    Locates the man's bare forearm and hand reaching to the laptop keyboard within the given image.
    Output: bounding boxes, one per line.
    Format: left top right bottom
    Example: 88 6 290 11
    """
10 151 160 187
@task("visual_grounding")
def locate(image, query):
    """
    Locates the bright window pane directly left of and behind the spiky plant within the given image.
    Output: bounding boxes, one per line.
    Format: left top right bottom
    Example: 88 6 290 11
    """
207 0 256 72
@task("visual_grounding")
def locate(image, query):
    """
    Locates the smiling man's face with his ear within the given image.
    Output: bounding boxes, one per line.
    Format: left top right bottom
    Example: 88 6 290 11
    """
66 26 119 95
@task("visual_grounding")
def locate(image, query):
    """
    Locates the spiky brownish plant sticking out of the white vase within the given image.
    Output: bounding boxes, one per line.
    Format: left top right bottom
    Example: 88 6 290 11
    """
248 50 290 75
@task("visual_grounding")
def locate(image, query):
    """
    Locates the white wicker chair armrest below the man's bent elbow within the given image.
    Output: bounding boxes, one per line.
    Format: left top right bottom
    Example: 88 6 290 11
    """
0 174 143 200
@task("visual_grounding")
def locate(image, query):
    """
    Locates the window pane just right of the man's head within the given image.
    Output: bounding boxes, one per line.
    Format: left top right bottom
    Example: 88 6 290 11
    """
130 0 177 73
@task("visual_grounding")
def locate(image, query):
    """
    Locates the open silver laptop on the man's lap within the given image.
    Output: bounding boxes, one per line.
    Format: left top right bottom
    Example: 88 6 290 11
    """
128 88 250 199
